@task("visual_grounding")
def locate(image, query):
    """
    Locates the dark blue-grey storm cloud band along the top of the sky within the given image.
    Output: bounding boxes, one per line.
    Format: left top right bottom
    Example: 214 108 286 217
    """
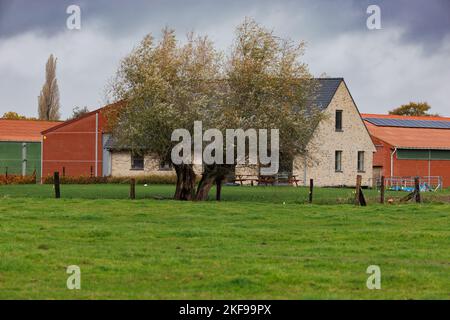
0 0 450 46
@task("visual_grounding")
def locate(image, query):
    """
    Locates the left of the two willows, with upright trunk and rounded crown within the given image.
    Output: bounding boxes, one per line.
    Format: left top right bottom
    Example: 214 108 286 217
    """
110 29 220 200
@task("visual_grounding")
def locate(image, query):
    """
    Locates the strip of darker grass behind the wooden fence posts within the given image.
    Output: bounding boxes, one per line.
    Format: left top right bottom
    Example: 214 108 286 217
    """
0 184 450 204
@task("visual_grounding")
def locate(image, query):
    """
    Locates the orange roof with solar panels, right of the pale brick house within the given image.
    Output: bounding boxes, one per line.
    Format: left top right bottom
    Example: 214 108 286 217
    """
362 114 450 150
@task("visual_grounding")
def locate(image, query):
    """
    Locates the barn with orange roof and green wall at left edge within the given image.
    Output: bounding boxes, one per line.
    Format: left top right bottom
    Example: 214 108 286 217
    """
0 119 60 177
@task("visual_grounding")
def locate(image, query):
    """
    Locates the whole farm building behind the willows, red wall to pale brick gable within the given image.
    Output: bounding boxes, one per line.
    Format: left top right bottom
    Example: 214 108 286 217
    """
42 78 375 186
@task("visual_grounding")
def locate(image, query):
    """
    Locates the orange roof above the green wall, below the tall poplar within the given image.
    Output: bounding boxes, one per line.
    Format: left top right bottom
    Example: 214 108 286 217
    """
0 119 61 142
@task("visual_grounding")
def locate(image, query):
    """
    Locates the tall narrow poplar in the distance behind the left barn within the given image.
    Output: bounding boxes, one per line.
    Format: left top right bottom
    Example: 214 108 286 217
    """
38 54 60 120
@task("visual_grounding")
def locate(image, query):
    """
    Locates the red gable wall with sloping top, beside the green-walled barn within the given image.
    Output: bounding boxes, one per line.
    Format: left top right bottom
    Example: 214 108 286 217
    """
42 113 105 177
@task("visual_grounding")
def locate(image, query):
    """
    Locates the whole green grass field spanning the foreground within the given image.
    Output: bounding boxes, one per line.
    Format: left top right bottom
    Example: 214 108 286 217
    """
0 185 450 299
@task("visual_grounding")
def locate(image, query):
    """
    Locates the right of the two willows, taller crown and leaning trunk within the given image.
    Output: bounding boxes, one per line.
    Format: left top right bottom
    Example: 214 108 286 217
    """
196 19 322 200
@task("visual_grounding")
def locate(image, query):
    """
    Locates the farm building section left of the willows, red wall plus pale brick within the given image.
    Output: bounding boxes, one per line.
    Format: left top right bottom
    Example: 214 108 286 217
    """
42 102 192 177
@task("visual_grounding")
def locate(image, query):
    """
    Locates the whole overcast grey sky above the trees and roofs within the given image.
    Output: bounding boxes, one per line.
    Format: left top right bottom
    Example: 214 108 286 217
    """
0 0 450 118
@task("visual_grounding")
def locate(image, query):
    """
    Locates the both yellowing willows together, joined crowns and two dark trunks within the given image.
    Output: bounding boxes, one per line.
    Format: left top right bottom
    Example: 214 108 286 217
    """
109 19 322 200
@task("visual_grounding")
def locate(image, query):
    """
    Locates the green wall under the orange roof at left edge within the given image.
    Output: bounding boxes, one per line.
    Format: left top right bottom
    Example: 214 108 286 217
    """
0 141 41 178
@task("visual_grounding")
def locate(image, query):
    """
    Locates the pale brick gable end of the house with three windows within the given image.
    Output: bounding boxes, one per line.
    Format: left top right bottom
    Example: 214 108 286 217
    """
292 78 376 187
